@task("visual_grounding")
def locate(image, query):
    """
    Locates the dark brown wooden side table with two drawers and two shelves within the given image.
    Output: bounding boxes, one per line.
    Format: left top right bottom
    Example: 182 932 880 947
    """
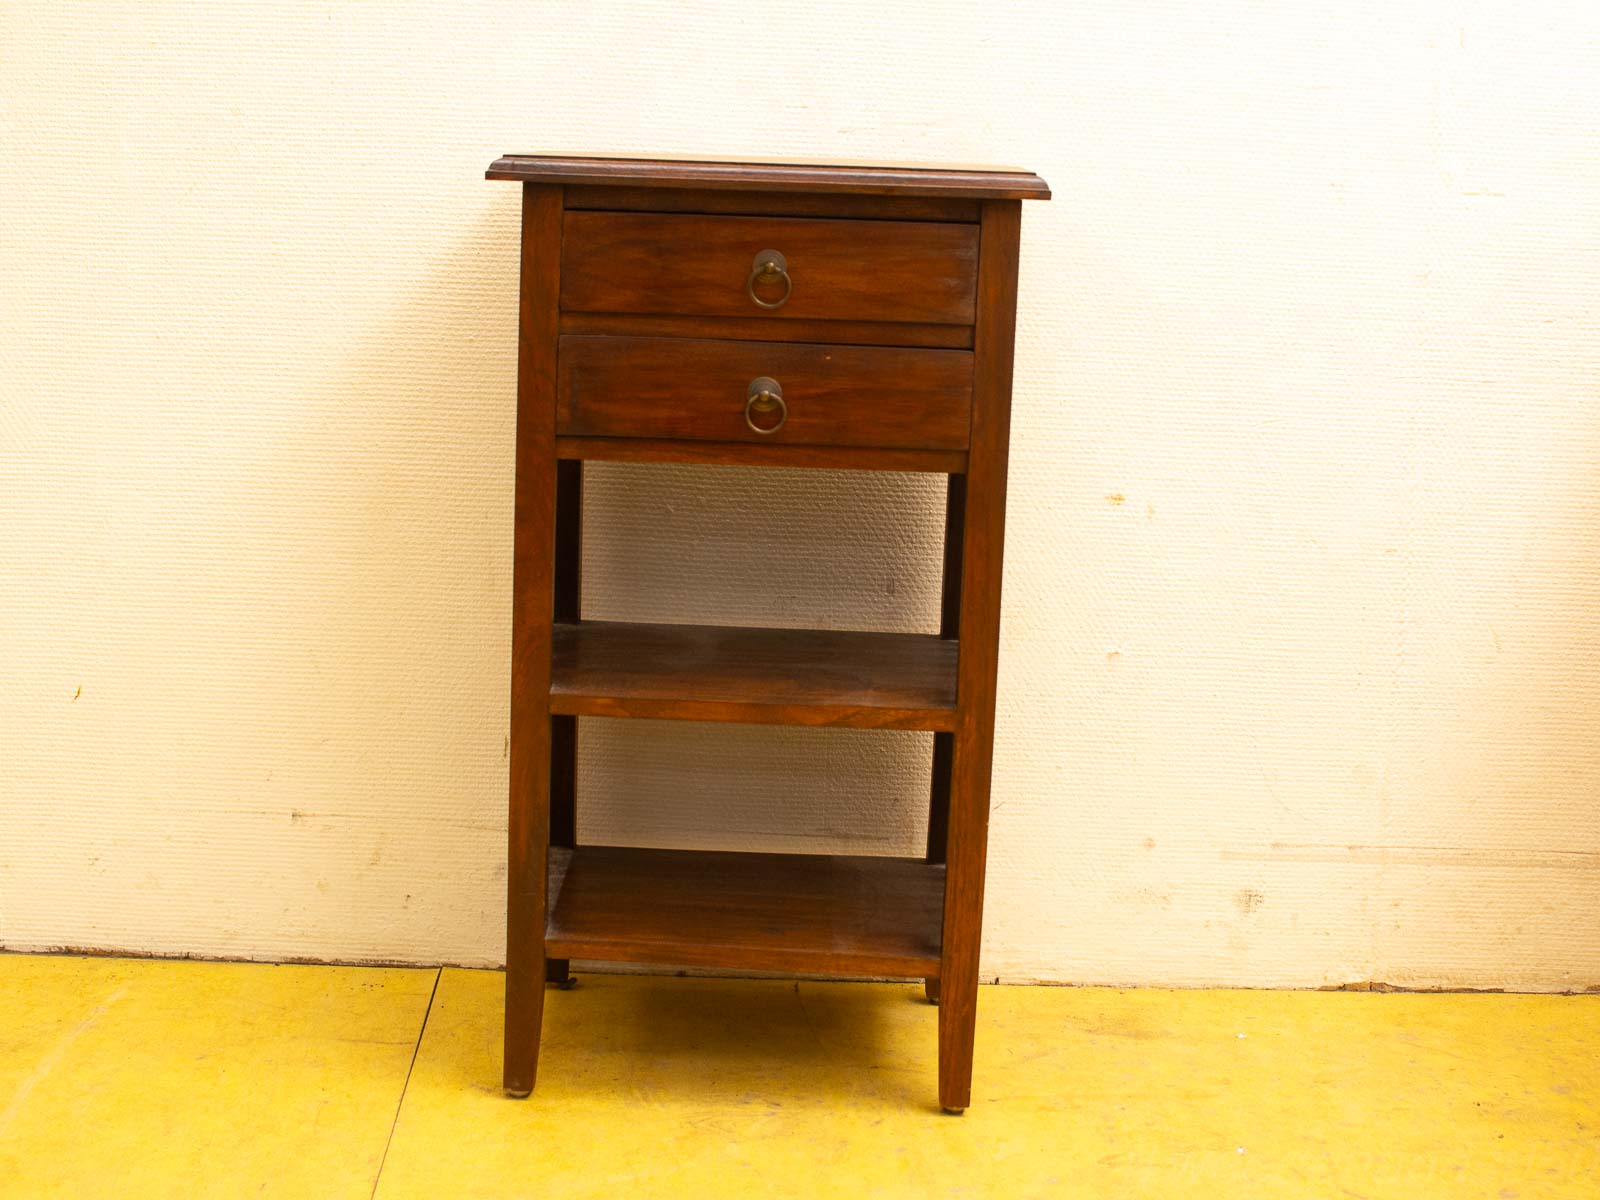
488 155 1050 1112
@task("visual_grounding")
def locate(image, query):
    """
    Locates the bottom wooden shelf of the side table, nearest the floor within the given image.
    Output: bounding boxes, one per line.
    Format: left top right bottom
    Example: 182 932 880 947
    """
544 846 944 978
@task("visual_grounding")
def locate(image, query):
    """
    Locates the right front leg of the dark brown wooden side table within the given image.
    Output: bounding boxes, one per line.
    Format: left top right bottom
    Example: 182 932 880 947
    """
939 200 1022 1112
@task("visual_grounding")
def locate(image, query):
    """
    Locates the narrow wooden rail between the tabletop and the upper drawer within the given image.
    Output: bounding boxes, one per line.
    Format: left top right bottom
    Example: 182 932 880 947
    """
566 187 978 224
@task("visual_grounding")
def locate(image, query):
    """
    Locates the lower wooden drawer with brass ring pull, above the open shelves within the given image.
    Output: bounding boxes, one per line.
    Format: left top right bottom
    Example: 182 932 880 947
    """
555 334 973 450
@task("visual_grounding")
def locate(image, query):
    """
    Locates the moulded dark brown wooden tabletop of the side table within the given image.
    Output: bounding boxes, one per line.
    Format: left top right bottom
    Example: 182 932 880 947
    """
485 154 1050 200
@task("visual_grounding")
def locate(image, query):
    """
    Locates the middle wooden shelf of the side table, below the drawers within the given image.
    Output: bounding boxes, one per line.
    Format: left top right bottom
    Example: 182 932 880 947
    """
550 621 957 731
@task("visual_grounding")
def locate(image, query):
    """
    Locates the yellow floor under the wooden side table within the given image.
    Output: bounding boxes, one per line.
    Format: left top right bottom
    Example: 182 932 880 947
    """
0 955 1600 1200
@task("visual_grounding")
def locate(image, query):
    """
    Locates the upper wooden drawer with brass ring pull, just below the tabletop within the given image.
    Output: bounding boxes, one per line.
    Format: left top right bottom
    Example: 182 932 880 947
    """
562 213 978 325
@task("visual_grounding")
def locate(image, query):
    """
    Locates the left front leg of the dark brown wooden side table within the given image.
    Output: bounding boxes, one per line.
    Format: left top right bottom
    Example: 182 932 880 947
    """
506 184 562 1096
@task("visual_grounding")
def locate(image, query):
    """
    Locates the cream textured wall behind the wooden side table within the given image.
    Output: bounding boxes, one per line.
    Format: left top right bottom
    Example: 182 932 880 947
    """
0 0 1600 989
